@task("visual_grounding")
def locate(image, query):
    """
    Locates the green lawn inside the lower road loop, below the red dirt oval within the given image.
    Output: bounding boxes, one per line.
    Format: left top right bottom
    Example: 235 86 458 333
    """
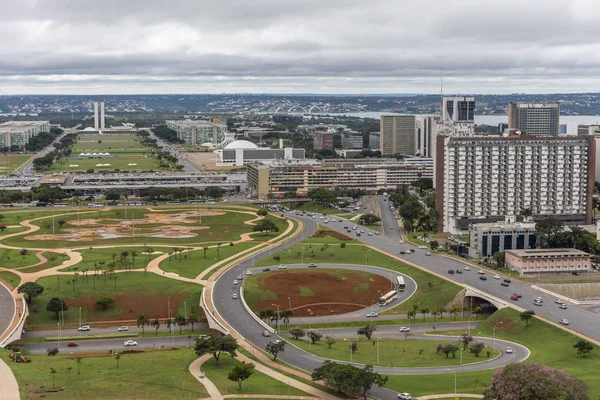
287 332 500 367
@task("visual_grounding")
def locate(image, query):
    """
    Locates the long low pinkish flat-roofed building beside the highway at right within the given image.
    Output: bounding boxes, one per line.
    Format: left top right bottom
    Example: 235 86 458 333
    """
505 249 591 276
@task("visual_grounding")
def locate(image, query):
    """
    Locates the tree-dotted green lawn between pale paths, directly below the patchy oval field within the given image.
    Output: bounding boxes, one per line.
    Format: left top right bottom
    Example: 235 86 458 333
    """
61 246 173 271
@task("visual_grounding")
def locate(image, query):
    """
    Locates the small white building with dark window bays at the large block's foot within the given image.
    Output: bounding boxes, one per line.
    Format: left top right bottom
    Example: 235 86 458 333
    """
469 222 537 258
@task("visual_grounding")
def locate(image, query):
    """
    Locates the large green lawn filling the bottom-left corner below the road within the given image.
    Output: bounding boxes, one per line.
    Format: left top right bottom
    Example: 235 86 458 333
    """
0 349 208 400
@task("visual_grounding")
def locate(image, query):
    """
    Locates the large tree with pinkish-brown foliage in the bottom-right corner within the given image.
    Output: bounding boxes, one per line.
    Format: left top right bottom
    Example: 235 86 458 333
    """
483 363 589 400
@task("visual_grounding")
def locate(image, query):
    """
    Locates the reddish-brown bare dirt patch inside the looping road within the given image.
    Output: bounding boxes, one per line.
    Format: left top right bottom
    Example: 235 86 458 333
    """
257 270 391 317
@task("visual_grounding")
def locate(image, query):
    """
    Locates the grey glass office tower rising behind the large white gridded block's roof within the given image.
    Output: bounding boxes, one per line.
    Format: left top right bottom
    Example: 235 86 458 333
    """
508 101 560 136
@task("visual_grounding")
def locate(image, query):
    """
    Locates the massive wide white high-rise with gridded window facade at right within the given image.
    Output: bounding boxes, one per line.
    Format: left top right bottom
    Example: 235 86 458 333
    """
435 136 595 233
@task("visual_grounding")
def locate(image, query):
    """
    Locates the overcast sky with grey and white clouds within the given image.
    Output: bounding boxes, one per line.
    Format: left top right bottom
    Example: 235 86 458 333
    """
0 0 600 94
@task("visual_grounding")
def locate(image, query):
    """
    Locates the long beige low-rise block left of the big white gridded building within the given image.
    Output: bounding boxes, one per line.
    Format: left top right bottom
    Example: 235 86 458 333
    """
247 158 433 199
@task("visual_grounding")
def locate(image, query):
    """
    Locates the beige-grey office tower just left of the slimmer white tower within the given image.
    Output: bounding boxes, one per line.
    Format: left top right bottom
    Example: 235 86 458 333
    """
379 115 416 155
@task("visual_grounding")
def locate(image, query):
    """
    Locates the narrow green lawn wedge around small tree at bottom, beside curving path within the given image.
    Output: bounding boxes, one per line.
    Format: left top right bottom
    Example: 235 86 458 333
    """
202 354 309 396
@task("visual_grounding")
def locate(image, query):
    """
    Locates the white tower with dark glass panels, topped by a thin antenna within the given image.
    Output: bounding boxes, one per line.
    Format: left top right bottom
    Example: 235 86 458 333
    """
439 96 475 137
